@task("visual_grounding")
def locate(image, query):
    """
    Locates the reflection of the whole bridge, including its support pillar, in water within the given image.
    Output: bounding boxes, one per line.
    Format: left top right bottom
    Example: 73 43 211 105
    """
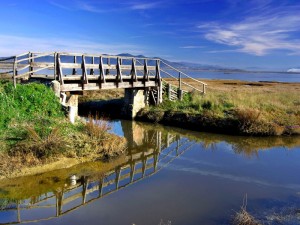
4 122 194 224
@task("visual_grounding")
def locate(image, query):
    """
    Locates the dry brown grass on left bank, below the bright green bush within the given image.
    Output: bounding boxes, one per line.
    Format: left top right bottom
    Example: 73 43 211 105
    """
0 118 126 177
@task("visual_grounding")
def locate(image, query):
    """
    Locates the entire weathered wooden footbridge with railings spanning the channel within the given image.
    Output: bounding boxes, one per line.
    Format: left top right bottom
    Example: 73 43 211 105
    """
0 52 206 118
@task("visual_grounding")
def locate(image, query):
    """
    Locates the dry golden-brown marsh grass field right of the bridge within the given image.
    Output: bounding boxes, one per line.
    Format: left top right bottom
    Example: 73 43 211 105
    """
158 79 300 135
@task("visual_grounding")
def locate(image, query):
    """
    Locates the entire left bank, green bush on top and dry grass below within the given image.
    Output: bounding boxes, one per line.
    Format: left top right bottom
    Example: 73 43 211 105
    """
0 82 125 177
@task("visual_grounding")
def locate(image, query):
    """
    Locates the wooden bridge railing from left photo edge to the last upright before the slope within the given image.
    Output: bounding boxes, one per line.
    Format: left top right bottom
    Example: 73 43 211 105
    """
0 52 161 91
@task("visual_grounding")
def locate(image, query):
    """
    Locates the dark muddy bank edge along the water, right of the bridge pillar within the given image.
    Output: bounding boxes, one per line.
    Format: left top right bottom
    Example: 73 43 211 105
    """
136 109 300 136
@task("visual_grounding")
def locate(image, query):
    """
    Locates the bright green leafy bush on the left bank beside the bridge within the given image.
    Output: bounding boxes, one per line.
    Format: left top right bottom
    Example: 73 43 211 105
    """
0 81 64 130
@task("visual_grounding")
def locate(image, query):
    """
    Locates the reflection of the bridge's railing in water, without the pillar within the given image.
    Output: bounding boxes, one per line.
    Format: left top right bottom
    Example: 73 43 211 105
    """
0 131 193 224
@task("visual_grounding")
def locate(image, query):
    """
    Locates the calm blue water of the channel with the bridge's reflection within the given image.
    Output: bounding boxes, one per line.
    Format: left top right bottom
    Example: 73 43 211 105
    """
0 121 300 225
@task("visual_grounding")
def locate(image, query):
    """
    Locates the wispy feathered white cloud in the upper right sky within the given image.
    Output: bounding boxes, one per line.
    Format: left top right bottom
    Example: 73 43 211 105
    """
198 4 300 56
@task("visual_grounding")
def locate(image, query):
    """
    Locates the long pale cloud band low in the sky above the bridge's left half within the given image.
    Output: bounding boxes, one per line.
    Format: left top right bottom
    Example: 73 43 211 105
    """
0 35 145 56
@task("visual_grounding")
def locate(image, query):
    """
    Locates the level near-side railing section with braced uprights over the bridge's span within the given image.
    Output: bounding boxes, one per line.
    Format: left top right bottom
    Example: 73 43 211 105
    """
56 53 160 89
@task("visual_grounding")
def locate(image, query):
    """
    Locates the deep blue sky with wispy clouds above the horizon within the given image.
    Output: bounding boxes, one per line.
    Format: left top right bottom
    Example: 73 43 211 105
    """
0 0 300 70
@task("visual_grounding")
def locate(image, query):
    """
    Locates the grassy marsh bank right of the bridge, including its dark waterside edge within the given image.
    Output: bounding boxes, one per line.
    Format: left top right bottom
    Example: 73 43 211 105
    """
82 79 300 136
